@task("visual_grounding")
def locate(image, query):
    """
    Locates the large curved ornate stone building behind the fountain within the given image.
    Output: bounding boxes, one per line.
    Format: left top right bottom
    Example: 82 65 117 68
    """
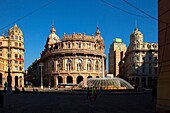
39 25 106 86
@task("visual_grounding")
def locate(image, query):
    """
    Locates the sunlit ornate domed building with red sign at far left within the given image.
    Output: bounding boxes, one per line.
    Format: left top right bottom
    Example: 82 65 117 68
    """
0 24 24 87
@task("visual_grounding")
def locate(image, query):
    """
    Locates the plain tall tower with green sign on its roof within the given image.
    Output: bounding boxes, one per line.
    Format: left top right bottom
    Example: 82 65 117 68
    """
108 38 126 76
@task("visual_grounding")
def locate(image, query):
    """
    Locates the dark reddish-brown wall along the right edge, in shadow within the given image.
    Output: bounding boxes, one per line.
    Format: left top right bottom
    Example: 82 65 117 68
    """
156 0 170 113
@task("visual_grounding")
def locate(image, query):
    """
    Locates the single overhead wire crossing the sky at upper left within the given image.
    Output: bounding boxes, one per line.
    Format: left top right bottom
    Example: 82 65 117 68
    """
0 0 56 30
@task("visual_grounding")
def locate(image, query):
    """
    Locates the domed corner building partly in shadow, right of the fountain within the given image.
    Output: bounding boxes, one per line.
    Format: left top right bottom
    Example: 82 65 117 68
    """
119 28 158 88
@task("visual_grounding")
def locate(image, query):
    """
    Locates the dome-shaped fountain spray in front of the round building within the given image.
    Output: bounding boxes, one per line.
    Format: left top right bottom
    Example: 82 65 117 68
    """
78 77 134 89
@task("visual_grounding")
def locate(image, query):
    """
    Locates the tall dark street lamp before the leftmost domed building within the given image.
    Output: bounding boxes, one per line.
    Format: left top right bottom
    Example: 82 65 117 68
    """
3 35 12 93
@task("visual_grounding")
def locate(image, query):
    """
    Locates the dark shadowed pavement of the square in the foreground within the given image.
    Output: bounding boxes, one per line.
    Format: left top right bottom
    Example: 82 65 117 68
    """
0 91 155 113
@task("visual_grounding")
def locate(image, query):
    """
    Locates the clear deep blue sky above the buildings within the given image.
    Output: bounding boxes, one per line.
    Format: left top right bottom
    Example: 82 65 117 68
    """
0 0 158 69
